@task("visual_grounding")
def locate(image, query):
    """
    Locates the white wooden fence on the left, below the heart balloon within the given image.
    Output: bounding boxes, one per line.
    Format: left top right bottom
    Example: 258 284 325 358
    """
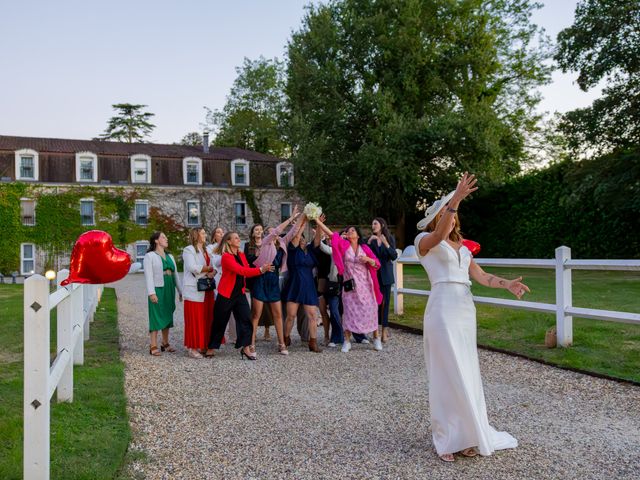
24 270 102 480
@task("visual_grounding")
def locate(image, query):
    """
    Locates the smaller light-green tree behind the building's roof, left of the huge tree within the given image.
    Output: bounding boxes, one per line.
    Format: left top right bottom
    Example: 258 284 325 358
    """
207 57 288 157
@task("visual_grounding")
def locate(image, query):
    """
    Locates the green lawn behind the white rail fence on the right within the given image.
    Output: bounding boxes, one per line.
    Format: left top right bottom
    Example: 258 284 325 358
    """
390 265 640 382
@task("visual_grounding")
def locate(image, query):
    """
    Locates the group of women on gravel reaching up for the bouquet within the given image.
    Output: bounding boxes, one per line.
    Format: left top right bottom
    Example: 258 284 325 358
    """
144 206 397 360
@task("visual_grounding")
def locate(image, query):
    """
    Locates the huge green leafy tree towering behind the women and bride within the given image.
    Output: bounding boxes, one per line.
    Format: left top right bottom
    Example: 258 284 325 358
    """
287 0 548 236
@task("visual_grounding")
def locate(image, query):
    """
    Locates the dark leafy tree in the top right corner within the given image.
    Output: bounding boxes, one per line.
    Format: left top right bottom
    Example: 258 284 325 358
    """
555 0 640 153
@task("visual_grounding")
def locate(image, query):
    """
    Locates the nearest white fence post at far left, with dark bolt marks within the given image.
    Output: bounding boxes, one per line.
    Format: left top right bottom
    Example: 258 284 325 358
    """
23 275 50 479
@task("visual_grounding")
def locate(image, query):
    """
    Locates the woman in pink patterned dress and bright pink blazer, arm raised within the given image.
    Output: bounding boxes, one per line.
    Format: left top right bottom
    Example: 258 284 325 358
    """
316 218 382 353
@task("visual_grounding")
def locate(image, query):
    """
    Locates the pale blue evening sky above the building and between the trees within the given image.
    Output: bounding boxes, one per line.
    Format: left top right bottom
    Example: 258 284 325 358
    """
0 0 599 143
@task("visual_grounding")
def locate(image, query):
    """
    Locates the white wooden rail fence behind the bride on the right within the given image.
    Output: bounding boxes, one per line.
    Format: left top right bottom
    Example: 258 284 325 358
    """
393 246 640 347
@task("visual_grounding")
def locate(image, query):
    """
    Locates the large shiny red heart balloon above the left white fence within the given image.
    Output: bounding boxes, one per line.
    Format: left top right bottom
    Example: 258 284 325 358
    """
61 230 131 286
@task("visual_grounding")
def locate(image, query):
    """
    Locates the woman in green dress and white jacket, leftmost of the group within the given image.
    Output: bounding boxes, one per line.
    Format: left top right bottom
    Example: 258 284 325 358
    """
143 232 182 356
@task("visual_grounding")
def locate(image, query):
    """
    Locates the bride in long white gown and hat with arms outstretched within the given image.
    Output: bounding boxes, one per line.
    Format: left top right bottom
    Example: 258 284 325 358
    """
415 173 529 462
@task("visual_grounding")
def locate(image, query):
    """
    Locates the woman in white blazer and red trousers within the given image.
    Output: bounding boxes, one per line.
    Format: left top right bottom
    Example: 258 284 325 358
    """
182 228 216 358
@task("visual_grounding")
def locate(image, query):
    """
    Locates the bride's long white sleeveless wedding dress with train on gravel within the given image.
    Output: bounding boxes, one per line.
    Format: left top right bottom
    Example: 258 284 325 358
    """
415 233 518 455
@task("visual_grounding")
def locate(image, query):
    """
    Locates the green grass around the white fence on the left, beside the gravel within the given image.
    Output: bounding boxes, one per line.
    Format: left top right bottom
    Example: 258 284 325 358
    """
0 285 130 480
